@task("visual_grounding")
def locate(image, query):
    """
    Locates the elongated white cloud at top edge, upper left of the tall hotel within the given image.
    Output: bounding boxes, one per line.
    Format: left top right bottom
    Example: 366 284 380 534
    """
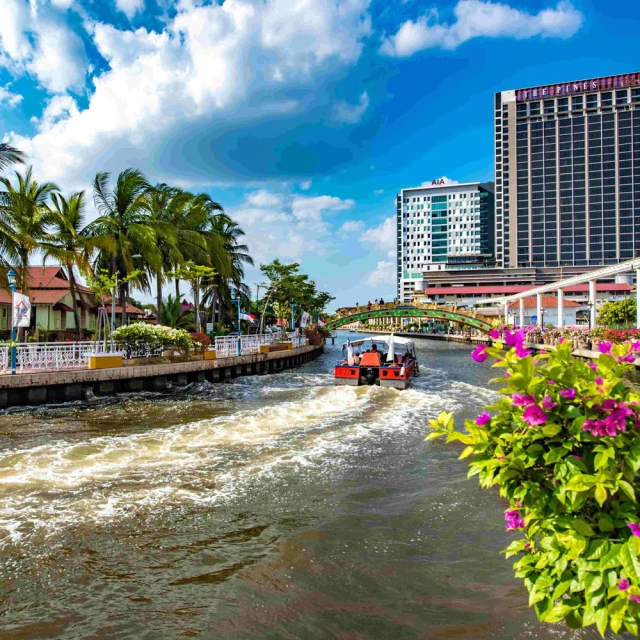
380 0 583 58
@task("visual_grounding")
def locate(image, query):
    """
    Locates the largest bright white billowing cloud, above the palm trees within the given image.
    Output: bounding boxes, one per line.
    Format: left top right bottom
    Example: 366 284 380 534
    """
7 0 371 190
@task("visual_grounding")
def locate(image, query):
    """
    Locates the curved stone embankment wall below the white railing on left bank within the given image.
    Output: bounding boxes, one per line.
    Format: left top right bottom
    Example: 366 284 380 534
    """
0 346 324 409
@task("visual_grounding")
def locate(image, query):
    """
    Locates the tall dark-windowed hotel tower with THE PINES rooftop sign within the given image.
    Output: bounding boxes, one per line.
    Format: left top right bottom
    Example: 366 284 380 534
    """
494 73 640 268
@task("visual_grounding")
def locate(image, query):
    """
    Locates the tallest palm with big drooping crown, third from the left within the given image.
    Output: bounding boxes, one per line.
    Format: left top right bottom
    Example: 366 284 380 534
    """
86 169 162 325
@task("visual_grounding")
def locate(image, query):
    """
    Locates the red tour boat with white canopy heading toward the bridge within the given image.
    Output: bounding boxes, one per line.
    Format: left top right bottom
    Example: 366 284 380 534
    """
334 334 419 389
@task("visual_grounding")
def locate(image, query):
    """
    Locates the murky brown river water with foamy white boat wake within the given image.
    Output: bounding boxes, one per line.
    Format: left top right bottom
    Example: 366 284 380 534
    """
0 334 597 640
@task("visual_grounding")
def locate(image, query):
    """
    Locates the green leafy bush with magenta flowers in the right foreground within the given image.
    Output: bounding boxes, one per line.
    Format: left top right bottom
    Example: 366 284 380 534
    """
427 331 640 636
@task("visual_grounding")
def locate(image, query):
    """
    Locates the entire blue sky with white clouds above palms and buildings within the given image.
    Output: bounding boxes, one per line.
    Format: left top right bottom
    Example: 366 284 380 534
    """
0 0 640 304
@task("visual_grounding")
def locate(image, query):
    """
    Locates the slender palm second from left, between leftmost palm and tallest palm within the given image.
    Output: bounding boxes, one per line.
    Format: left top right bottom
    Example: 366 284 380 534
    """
41 191 115 340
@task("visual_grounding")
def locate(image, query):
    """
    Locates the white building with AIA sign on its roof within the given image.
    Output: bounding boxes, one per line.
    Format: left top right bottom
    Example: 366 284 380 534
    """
396 178 495 302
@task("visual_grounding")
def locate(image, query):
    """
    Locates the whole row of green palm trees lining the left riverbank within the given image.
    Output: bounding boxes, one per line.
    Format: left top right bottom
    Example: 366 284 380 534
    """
0 143 253 327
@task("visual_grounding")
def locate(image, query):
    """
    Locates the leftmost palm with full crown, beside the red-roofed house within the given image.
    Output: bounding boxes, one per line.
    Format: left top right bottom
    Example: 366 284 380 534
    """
0 167 59 292
